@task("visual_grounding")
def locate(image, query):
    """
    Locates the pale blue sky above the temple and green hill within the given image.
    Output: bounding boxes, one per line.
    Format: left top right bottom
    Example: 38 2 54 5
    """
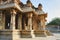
21 0 60 22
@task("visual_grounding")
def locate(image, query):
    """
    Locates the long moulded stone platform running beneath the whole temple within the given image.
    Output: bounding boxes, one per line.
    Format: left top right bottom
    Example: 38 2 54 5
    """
0 29 53 40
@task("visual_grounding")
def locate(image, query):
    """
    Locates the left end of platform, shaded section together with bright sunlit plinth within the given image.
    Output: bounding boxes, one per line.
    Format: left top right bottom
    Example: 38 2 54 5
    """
0 29 20 40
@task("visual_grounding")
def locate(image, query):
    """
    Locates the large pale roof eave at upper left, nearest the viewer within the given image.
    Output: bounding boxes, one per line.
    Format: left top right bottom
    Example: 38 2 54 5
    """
0 3 22 11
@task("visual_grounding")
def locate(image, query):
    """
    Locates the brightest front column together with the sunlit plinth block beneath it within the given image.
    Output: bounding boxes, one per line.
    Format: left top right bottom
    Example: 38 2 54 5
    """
11 9 20 40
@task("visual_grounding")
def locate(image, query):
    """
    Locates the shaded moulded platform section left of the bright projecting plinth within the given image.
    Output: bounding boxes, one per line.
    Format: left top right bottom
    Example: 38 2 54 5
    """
0 30 12 40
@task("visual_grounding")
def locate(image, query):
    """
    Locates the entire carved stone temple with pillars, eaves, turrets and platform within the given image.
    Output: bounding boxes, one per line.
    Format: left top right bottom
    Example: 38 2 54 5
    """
0 0 50 40
